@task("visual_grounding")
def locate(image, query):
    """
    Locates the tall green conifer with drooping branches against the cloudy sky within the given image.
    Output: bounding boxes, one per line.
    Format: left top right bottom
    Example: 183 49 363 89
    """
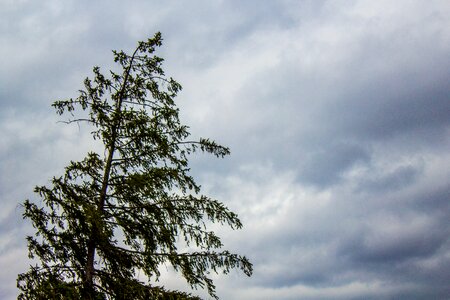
17 33 252 299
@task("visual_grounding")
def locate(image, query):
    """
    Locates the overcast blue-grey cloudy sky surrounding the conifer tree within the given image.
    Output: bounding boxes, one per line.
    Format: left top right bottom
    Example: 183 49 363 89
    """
0 0 450 300
